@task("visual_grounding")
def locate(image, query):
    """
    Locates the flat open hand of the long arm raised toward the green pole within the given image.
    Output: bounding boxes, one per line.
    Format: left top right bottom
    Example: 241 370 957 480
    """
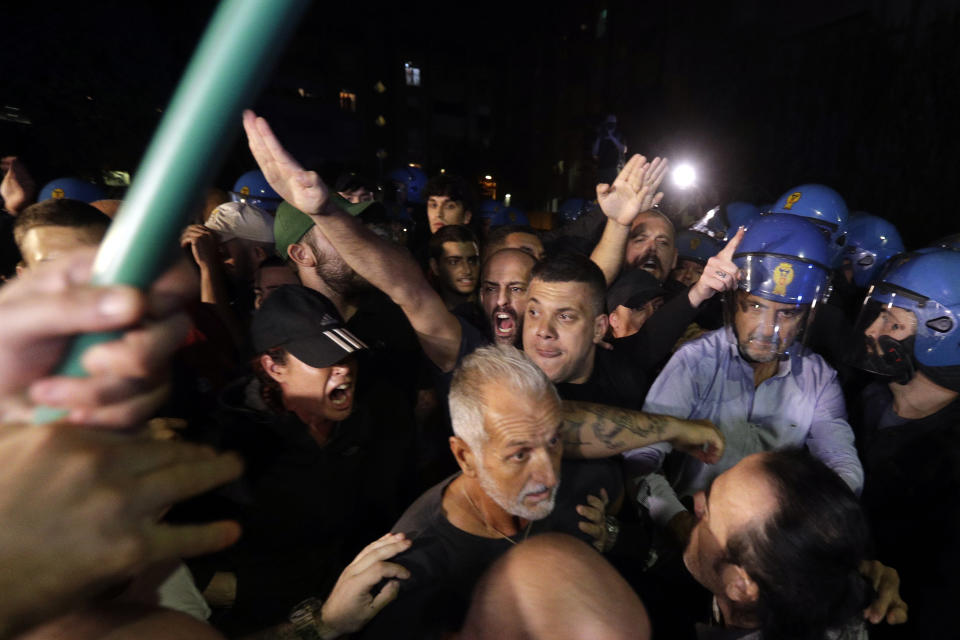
243 110 330 214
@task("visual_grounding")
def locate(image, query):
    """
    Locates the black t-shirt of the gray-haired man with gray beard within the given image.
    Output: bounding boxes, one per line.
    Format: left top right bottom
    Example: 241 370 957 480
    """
362 460 622 638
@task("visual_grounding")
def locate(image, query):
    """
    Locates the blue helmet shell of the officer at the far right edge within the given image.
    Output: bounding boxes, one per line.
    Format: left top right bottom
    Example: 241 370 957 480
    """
864 249 960 370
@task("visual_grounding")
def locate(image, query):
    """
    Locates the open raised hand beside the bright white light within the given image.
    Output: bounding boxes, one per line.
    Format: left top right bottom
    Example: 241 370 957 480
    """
597 155 667 226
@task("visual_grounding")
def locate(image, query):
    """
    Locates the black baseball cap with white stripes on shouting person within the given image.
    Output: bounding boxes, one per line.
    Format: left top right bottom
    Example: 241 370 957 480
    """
250 284 367 369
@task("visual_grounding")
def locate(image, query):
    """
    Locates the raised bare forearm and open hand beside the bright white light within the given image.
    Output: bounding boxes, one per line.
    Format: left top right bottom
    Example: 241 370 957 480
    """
590 155 667 286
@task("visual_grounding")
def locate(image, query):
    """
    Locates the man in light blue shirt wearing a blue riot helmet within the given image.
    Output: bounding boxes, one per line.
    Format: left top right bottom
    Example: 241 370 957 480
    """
626 214 863 543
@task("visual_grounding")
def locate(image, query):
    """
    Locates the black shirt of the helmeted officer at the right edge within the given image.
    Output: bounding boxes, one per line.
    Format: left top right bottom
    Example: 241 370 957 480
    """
856 383 960 638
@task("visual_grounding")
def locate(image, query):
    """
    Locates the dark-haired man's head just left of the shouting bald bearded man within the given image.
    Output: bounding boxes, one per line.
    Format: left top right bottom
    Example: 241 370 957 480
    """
428 224 480 311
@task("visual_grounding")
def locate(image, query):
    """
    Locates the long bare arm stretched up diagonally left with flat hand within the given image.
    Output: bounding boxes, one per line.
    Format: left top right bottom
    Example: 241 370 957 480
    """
243 111 461 371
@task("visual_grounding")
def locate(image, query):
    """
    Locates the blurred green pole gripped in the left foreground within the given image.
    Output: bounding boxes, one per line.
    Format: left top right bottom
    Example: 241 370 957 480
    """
34 0 309 424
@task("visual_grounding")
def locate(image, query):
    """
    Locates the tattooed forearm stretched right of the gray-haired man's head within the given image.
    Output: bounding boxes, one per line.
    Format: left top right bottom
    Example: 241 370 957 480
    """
561 402 671 458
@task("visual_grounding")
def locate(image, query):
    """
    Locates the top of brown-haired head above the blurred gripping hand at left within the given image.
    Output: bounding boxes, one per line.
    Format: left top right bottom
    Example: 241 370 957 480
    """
13 198 110 272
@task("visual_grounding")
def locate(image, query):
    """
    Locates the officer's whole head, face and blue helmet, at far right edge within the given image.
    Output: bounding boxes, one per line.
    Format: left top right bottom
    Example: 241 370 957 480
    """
854 249 960 391
